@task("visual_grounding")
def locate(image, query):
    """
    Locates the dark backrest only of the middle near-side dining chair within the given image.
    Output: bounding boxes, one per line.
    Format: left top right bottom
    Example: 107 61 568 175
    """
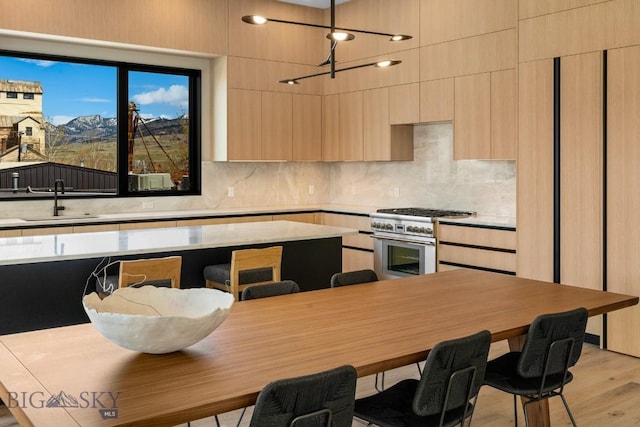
412 330 491 416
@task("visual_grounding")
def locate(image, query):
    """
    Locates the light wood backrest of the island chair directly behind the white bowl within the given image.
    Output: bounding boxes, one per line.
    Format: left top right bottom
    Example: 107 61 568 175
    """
118 256 182 288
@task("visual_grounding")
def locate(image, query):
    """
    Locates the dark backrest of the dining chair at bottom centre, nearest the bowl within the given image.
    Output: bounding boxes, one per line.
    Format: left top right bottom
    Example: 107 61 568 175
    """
249 365 357 427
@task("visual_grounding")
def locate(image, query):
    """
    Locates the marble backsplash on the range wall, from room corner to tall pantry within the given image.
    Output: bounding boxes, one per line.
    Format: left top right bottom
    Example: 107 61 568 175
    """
330 123 516 217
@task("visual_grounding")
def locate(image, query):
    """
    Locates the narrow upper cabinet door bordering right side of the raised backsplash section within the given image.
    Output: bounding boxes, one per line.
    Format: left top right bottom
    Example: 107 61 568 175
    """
453 73 491 160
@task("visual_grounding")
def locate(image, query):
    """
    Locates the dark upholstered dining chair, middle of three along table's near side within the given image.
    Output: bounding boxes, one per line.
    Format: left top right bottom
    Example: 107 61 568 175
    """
354 331 491 427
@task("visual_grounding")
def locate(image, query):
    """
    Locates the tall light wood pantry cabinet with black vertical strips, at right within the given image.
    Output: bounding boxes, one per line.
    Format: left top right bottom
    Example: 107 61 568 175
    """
518 47 640 356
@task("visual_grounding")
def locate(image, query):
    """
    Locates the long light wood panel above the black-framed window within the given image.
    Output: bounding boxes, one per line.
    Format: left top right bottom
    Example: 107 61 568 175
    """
0 0 234 55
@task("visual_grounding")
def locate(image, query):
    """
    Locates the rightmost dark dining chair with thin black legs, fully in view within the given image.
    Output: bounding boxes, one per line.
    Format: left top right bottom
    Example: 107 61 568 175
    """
485 308 588 427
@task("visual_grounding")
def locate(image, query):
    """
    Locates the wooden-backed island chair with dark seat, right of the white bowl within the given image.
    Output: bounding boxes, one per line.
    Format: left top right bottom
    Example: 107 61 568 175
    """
203 246 282 301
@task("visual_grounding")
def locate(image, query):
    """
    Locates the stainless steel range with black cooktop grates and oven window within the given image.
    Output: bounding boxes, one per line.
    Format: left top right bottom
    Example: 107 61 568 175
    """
369 208 475 279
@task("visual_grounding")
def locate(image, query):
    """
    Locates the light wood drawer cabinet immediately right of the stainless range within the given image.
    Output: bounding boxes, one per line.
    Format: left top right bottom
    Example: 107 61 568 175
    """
437 223 516 274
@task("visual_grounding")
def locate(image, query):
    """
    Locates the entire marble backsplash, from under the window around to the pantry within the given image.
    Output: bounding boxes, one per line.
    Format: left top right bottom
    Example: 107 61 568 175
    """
0 123 516 218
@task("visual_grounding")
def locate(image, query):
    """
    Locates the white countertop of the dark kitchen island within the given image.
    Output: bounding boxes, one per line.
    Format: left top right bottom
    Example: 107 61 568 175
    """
0 221 357 265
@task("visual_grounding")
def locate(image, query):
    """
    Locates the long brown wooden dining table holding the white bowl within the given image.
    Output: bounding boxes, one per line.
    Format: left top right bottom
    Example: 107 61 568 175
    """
0 270 638 427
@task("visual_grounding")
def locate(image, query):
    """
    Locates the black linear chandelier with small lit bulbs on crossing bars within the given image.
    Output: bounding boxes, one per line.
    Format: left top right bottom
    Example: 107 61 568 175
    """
242 0 412 84
